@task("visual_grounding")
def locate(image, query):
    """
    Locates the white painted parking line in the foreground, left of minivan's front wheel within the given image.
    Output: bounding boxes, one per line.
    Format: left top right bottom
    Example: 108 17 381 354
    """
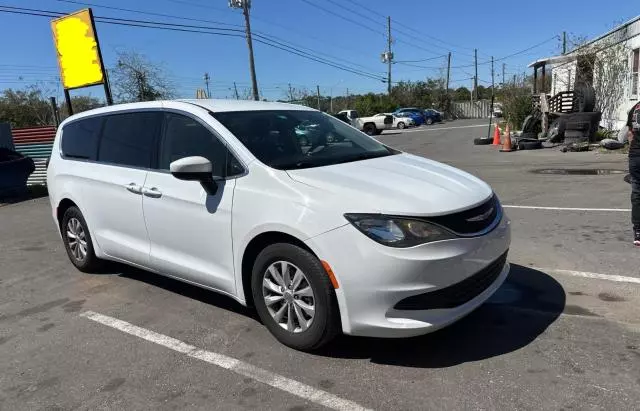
80 311 366 411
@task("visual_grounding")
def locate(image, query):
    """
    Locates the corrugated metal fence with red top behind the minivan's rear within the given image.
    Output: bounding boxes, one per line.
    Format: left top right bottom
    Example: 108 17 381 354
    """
11 126 56 185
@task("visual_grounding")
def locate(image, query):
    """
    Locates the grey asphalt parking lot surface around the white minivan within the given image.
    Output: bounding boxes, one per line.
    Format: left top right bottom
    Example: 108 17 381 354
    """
0 120 640 411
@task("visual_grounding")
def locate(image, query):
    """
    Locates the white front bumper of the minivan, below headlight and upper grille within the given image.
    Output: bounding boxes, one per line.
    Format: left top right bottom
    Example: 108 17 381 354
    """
307 216 511 338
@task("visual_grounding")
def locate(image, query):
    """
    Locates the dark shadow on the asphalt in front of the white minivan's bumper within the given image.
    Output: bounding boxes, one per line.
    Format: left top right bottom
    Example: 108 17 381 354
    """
317 264 566 368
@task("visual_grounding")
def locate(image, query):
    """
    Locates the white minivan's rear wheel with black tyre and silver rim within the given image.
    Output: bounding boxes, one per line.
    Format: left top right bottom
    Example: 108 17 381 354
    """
60 207 102 273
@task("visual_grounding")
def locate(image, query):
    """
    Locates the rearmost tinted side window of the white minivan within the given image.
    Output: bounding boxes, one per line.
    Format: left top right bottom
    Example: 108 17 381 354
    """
62 117 102 160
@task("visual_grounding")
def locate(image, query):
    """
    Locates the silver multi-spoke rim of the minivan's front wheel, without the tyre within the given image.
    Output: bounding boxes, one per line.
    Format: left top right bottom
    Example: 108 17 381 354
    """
262 261 316 333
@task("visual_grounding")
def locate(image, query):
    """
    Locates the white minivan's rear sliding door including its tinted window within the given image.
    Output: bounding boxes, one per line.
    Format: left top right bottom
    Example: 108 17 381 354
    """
74 111 162 267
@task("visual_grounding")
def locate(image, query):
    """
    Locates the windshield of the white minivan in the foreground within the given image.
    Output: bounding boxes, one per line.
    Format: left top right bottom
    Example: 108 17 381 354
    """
212 110 397 170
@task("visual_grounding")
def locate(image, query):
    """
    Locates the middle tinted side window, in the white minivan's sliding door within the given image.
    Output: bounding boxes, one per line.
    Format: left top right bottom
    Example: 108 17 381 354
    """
98 111 162 168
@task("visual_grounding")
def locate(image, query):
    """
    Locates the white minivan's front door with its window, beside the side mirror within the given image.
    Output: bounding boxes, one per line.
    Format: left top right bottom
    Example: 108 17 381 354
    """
143 111 236 295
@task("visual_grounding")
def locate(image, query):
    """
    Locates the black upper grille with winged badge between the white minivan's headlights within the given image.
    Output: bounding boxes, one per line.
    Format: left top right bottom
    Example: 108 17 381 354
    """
426 195 502 236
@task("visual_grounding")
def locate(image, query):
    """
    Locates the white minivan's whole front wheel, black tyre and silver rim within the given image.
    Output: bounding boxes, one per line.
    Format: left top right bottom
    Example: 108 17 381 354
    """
251 243 340 351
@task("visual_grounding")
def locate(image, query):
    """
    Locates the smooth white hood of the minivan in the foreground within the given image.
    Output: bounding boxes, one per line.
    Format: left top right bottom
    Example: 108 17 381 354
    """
287 153 493 216
